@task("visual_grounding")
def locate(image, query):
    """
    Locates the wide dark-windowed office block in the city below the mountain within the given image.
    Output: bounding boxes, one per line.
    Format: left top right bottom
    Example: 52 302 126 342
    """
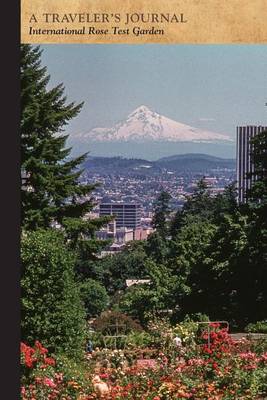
99 203 141 229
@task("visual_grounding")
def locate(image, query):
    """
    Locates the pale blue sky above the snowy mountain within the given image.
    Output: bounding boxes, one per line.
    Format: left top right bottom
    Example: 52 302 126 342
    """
41 44 267 143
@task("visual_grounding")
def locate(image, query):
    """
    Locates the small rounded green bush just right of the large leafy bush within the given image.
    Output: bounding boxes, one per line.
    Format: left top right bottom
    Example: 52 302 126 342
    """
80 279 109 318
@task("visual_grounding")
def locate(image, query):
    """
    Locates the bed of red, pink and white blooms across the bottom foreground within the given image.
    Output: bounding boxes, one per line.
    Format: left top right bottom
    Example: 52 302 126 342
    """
22 326 267 400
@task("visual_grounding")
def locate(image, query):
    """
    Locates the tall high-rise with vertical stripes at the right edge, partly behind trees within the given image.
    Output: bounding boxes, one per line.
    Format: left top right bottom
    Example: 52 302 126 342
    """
236 125 267 203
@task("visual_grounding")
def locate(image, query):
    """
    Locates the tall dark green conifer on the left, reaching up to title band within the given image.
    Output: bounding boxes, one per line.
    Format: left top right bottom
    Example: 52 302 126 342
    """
21 44 110 254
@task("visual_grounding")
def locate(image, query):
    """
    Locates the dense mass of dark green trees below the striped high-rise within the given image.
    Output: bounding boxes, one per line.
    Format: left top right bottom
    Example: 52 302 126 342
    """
96 172 267 329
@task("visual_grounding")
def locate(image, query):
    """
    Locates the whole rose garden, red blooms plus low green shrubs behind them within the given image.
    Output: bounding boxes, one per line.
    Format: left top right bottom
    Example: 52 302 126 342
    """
21 319 267 400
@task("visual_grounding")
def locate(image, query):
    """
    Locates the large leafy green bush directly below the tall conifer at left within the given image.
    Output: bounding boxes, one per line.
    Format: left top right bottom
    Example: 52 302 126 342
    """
21 230 85 357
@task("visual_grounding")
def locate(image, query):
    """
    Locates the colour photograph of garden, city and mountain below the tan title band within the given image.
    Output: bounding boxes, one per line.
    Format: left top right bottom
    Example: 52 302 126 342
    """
20 32 267 400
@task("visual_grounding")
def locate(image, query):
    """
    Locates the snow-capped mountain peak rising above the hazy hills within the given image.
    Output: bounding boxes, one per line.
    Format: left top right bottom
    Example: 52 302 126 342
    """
75 105 232 143
